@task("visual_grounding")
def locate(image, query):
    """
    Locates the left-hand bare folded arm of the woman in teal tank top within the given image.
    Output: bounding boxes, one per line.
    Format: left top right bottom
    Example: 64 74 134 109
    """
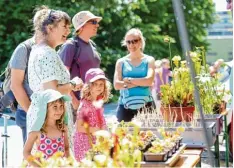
114 59 136 90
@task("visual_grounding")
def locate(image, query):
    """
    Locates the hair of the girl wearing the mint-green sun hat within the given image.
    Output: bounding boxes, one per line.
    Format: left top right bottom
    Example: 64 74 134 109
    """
41 98 65 133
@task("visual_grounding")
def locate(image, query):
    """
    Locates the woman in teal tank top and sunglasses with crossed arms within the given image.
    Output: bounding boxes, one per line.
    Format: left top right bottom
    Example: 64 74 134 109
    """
114 28 155 121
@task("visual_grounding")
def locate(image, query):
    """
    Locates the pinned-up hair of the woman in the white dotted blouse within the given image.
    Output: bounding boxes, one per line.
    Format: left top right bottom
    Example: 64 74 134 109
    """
33 5 71 35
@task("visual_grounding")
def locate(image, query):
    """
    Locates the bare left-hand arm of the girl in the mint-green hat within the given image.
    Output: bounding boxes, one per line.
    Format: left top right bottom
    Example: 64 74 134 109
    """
23 131 40 167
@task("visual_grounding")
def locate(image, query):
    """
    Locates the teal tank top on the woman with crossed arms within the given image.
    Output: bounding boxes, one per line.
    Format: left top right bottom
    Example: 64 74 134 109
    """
119 57 152 104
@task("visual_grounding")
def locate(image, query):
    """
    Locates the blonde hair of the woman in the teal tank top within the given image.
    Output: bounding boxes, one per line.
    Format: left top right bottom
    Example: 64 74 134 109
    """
121 28 145 51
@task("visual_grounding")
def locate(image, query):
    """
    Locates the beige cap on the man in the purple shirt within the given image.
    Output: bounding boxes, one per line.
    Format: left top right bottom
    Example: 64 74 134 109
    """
72 11 102 31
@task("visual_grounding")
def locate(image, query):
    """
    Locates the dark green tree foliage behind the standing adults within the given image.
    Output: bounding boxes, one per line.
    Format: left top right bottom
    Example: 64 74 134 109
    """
0 0 214 100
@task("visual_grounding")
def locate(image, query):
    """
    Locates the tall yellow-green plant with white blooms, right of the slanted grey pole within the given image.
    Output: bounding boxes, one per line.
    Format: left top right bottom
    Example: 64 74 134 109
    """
190 47 230 114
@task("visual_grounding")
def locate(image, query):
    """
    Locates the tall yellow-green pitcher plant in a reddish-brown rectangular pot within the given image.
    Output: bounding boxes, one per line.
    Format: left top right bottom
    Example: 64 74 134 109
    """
160 56 195 121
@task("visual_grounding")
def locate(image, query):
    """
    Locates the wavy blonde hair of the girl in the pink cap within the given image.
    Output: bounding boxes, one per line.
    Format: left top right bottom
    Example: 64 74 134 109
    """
81 79 111 102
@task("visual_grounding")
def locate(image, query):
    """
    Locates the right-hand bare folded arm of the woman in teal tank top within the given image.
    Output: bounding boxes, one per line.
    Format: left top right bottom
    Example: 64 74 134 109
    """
123 56 155 86
